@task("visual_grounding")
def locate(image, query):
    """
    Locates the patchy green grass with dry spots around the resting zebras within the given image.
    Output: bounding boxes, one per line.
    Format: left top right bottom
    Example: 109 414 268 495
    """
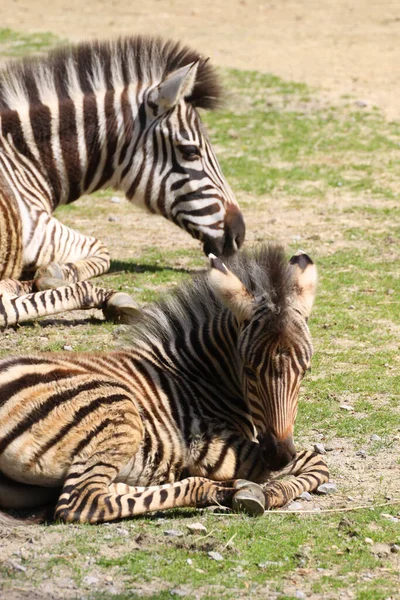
0 30 400 600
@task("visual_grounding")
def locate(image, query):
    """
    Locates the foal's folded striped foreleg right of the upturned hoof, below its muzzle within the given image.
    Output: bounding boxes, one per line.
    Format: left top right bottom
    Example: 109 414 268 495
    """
262 450 329 509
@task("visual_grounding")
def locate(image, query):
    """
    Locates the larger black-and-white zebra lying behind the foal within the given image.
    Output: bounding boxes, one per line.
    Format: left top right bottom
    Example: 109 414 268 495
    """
0 36 245 327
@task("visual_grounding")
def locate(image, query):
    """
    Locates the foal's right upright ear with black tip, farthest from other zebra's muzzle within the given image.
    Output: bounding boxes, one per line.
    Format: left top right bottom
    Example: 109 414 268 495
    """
289 250 317 319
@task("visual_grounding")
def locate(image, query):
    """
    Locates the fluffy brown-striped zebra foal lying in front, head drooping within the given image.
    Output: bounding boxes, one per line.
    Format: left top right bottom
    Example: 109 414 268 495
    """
0 245 329 523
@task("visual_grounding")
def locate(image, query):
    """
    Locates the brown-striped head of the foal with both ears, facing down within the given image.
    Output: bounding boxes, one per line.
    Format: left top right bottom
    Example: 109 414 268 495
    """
210 252 317 470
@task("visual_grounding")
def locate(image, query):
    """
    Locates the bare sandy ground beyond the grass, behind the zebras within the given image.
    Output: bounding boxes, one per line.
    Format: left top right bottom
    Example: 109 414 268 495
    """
0 0 400 119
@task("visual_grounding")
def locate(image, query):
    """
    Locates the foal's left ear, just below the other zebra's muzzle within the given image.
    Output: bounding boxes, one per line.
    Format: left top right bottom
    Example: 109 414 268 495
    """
208 254 254 322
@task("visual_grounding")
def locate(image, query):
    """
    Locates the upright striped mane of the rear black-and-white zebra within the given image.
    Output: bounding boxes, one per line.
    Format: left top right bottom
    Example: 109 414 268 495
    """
0 35 223 110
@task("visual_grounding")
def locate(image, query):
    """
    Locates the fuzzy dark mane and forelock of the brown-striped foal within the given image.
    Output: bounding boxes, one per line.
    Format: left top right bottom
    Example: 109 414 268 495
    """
124 244 294 345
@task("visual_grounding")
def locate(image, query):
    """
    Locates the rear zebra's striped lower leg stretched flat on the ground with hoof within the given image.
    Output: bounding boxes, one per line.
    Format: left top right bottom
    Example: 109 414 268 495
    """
0 281 139 328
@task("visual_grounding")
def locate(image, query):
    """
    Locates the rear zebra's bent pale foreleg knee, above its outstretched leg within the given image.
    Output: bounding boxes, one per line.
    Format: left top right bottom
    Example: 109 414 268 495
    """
28 215 110 283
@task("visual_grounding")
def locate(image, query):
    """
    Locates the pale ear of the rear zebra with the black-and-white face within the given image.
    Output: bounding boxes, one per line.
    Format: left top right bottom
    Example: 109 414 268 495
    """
151 58 201 110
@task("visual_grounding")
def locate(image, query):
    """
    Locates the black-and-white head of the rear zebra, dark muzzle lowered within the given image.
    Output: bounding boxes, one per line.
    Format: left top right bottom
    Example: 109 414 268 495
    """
127 58 245 256
